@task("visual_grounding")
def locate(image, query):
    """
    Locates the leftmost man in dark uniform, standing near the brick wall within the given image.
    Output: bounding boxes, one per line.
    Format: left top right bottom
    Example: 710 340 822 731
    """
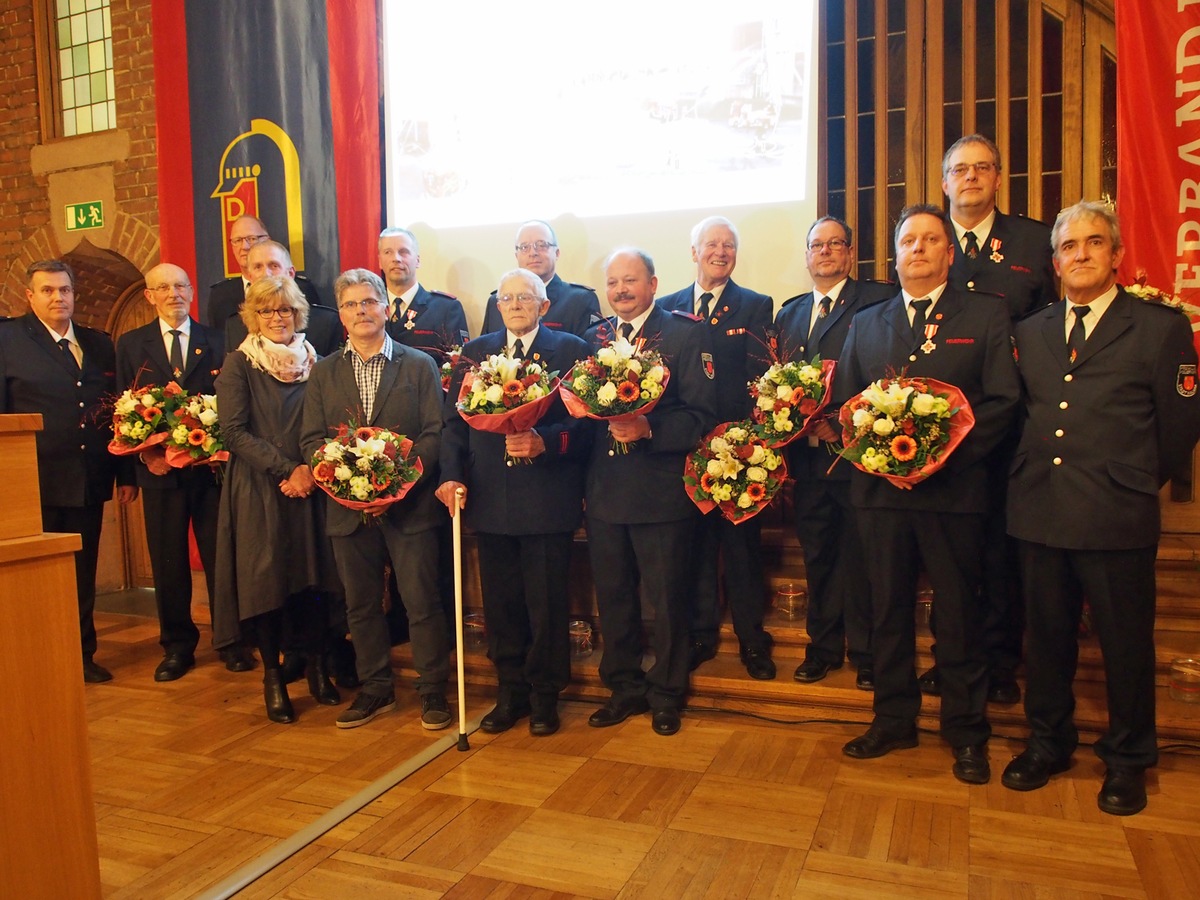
0 259 137 684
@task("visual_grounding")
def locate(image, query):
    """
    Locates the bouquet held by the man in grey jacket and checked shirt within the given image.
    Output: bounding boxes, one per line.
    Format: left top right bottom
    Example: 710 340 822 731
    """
312 425 425 522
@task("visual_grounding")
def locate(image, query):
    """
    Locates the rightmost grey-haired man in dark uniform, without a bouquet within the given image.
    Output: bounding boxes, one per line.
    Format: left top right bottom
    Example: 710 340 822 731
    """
1002 202 1200 816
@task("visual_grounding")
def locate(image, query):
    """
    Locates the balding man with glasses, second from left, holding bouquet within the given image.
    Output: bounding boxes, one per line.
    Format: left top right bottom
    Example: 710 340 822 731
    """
116 263 231 682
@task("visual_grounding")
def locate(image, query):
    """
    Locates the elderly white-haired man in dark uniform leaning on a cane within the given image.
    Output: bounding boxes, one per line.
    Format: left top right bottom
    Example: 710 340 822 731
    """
438 269 593 736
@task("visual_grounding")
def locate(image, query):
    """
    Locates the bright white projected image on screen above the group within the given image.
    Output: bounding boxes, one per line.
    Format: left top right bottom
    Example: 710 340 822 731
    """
383 0 815 228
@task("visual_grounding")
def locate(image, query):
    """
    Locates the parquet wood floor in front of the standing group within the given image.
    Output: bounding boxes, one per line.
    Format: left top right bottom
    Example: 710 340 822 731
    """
87 613 1200 900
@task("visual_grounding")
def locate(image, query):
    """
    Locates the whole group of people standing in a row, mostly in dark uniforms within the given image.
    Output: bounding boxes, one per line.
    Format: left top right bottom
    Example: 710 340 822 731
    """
0 134 1200 815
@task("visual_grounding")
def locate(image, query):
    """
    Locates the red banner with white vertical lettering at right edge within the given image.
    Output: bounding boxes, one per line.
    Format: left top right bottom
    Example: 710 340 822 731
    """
1116 0 1200 346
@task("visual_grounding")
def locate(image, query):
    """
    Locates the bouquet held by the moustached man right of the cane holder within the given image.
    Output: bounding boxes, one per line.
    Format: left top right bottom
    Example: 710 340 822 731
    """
563 337 671 456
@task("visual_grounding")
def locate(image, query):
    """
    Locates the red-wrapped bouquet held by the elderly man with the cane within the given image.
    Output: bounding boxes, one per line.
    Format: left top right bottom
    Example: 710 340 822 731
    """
456 354 558 466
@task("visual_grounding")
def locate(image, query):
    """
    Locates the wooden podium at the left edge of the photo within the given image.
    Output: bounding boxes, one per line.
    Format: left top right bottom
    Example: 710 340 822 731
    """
0 414 100 898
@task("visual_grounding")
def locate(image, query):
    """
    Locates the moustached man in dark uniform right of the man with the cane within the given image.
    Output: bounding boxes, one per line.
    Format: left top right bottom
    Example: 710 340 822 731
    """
586 247 718 734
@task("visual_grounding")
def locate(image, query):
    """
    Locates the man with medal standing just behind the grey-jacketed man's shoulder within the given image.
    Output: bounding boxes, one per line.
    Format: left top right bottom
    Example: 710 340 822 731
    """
379 228 470 364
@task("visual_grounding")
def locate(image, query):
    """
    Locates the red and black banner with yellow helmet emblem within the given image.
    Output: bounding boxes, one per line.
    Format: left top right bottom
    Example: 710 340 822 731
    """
152 0 382 316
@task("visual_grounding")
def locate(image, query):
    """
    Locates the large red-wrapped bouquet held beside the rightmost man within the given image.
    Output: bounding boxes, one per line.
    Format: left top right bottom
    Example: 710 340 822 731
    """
840 376 974 487
